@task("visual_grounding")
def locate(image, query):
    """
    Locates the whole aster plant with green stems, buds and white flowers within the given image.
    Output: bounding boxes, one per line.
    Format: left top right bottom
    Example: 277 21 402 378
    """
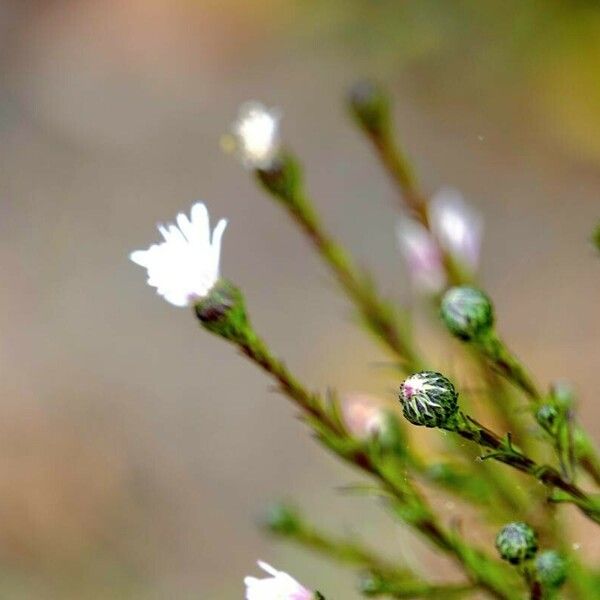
131 82 600 600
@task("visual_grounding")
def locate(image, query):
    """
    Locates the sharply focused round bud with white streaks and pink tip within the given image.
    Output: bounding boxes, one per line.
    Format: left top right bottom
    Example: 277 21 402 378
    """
399 371 458 427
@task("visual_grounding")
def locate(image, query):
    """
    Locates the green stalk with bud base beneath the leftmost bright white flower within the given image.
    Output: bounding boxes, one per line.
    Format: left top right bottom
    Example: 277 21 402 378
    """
194 283 513 599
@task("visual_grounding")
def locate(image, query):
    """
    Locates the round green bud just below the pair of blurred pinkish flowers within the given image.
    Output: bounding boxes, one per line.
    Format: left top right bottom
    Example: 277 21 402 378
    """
441 286 494 340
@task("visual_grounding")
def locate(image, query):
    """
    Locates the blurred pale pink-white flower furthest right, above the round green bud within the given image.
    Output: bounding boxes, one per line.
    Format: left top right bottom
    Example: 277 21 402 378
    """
429 188 483 272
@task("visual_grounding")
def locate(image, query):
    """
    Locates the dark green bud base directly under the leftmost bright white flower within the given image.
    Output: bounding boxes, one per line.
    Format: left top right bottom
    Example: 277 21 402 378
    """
194 279 248 340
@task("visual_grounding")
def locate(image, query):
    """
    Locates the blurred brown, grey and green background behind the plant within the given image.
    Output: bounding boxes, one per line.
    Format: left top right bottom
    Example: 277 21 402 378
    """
0 0 600 600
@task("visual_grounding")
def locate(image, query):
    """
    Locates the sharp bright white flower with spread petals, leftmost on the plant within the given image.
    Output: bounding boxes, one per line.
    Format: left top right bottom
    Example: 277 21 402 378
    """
129 202 227 306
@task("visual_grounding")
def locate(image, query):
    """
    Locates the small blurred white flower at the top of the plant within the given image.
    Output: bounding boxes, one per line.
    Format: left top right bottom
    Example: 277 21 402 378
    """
233 102 281 169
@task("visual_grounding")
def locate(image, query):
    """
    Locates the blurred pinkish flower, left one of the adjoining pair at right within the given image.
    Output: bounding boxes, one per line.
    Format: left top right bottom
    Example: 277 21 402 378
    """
396 217 446 293
